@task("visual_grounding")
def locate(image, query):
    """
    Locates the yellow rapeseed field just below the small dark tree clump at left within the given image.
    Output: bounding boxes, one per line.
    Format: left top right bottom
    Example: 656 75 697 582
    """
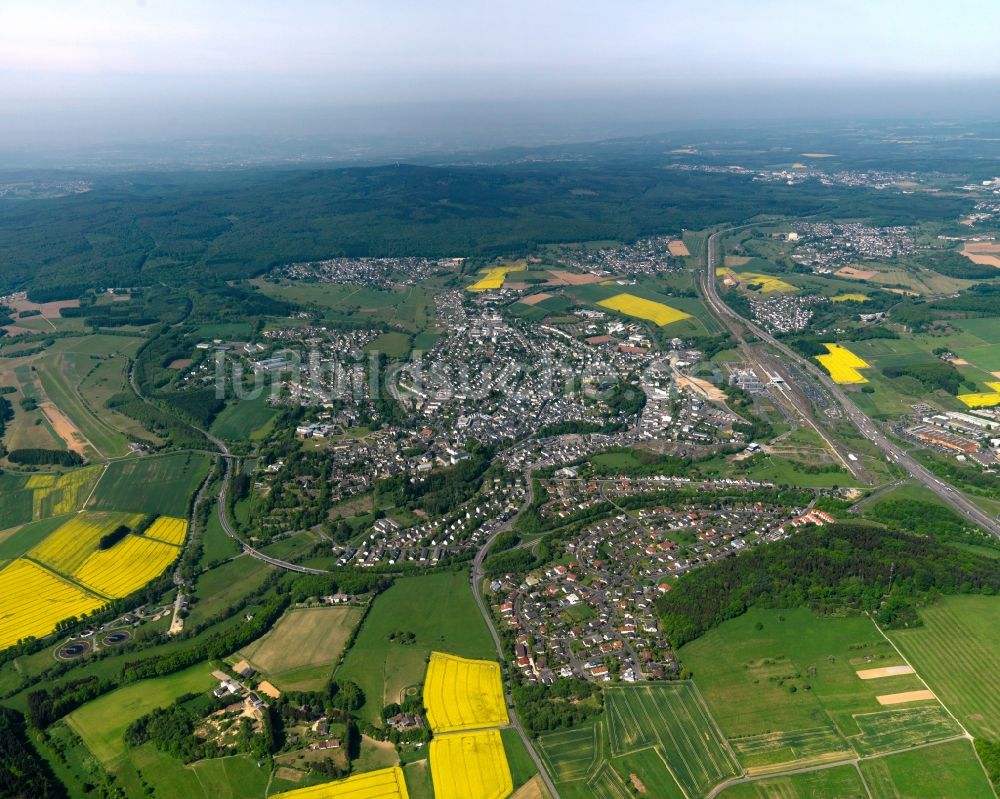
73 535 181 598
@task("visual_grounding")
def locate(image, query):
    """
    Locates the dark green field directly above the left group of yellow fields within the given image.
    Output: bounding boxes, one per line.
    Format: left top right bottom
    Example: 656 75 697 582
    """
87 452 210 518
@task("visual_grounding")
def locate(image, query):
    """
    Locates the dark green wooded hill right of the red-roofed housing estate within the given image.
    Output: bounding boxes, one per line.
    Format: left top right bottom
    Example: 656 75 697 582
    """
657 524 1000 646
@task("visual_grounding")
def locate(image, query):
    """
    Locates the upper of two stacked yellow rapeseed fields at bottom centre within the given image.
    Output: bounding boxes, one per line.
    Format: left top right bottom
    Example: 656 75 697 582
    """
424 652 509 733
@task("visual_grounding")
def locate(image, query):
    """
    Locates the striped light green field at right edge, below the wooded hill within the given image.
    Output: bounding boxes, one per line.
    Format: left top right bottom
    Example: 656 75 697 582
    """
889 596 1000 740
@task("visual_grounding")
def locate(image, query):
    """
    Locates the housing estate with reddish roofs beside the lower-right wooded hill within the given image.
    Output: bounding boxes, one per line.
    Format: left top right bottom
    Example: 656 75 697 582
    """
490 490 833 684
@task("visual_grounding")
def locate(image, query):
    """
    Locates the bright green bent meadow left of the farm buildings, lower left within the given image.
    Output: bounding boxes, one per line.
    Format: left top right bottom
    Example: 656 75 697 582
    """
66 663 216 770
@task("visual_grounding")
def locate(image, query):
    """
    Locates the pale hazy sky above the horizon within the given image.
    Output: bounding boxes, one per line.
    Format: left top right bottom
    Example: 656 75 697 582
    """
0 0 1000 159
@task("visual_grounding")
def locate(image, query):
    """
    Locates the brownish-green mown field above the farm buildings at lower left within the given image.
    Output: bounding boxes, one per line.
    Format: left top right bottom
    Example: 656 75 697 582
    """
239 607 363 691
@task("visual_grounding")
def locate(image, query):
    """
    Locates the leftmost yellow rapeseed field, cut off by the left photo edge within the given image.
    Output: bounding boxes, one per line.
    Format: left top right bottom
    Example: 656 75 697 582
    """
0 558 104 649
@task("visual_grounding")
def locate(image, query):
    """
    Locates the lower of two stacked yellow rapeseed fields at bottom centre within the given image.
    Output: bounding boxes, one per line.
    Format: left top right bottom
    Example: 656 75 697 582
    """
430 730 514 799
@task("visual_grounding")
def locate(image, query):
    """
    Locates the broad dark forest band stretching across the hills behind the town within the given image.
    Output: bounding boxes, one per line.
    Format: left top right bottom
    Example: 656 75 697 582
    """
0 162 963 296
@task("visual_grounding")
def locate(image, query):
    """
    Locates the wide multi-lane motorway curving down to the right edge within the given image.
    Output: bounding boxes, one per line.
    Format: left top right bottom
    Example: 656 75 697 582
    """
701 225 1000 538
